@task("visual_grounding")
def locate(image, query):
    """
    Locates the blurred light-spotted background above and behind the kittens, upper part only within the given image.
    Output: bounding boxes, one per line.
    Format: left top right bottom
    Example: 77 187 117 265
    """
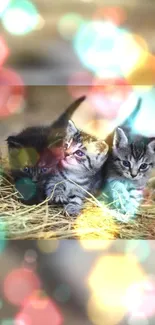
0 0 155 154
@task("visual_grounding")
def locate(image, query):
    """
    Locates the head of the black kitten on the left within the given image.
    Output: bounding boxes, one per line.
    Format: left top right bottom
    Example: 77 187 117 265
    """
7 127 61 182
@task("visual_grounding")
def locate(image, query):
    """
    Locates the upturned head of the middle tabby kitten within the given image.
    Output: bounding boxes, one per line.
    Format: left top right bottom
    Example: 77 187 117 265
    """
61 120 108 175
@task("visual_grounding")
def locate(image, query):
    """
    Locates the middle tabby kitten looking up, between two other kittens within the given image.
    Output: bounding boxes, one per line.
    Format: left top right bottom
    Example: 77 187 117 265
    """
46 121 108 216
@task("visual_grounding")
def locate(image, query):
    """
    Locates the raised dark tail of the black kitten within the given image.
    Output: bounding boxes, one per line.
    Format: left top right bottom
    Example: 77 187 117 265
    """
52 96 86 129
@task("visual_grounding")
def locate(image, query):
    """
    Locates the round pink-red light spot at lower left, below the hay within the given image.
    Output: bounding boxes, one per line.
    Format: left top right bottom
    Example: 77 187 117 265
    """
3 268 41 305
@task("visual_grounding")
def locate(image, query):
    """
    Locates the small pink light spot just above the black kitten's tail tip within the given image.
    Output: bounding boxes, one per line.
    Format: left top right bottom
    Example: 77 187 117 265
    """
68 71 93 98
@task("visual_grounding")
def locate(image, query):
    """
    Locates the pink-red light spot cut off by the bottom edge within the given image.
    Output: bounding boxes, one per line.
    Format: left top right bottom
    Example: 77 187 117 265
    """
16 293 63 325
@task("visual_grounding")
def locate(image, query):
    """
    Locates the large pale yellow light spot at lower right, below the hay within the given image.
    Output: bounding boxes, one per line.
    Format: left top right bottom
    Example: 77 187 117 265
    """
88 255 145 325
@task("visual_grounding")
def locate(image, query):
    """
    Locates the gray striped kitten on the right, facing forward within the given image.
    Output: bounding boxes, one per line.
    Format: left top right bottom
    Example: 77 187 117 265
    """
104 128 155 216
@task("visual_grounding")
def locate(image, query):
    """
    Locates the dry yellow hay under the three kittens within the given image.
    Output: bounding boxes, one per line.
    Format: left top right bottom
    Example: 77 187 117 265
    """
0 159 155 239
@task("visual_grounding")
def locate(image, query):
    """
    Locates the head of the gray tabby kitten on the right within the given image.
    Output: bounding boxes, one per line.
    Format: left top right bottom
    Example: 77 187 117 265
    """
112 128 155 180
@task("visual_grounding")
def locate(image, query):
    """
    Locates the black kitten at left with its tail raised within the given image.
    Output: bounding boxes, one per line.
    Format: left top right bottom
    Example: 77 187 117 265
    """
7 96 85 204
